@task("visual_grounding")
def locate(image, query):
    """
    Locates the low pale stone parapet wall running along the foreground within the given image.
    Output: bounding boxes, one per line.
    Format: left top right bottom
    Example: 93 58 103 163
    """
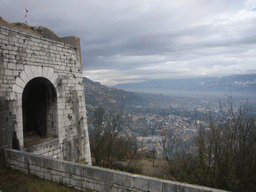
3 149 226 192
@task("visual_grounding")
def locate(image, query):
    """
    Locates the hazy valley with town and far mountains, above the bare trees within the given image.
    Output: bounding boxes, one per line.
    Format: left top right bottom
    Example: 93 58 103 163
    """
84 74 256 140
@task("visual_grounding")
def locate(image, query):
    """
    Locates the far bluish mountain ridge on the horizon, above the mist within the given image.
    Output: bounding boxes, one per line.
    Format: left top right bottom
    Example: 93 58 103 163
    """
114 74 256 93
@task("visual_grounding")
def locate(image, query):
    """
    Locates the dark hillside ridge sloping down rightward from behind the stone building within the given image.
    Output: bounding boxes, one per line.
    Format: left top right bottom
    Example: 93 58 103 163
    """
83 77 179 108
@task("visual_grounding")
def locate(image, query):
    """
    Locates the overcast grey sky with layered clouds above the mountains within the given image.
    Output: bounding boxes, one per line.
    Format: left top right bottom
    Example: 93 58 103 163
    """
0 0 256 85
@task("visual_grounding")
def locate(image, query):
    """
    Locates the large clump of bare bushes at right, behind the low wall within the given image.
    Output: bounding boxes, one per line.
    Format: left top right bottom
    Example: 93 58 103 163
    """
162 97 256 191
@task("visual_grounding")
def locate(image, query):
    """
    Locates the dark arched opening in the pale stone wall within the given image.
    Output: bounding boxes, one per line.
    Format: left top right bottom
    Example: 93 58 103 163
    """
22 77 58 146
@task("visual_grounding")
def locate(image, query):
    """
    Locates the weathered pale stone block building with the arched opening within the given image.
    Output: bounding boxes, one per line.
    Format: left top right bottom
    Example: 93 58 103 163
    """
0 22 91 164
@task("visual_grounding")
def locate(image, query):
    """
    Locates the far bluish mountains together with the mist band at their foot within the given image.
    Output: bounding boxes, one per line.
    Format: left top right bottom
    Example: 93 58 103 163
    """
115 74 256 102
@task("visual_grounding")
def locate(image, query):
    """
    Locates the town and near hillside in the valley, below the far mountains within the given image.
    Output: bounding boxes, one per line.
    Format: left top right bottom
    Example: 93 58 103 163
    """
84 74 256 156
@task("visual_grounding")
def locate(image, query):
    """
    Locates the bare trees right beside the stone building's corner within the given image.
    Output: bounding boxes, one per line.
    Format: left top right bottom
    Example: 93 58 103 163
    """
89 107 134 168
